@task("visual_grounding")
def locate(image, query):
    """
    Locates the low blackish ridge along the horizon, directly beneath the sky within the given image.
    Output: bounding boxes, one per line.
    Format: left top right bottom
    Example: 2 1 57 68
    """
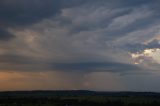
0 90 160 97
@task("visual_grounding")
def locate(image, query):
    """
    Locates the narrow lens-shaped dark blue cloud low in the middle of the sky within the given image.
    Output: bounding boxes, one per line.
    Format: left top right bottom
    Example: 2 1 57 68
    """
52 62 140 73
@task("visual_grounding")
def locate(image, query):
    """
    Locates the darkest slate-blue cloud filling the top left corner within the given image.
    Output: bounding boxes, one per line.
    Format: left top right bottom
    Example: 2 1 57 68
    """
0 0 85 26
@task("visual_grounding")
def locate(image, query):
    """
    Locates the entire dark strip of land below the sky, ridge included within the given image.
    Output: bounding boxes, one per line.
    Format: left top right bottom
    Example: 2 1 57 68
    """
0 91 160 106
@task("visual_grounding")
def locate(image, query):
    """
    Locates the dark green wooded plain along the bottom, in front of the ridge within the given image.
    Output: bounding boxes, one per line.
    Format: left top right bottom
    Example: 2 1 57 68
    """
0 96 160 106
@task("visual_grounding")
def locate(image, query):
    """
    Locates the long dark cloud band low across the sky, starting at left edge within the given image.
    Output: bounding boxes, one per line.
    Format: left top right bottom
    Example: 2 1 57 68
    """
0 54 140 73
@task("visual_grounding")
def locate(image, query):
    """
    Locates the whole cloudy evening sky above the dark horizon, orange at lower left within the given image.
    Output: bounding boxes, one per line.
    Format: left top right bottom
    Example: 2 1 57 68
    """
0 0 160 92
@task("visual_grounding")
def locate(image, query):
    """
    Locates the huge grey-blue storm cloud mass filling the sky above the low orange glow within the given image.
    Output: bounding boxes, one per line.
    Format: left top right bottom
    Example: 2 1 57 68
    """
0 0 159 72
